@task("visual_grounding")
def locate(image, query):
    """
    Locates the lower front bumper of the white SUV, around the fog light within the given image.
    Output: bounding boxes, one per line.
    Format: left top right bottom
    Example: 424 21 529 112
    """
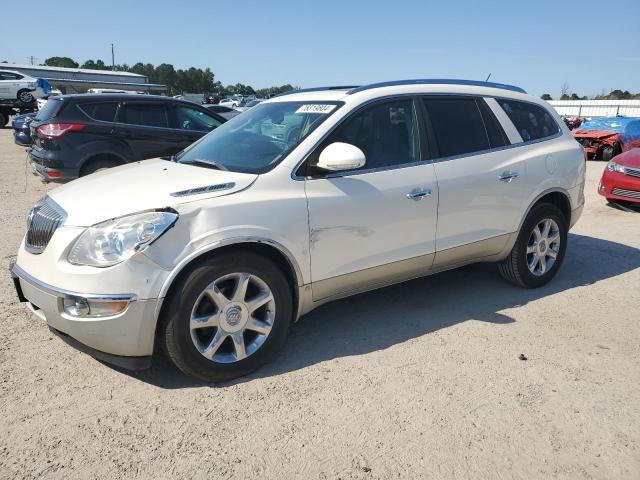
11 264 158 370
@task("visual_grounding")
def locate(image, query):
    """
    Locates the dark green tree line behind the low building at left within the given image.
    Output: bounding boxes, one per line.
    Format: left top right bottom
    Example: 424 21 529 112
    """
43 57 296 97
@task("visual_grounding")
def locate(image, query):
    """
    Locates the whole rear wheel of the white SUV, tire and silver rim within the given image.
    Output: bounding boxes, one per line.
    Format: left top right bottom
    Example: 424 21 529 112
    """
498 203 568 288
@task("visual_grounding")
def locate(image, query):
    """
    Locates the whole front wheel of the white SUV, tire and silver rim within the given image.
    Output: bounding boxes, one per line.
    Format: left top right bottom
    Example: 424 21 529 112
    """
159 252 292 382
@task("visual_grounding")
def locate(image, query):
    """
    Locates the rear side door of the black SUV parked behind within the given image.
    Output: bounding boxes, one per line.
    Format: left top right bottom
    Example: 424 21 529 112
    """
111 101 181 160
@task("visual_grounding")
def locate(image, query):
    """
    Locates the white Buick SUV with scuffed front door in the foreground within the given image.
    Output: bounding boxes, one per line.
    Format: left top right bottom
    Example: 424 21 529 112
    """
12 80 585 381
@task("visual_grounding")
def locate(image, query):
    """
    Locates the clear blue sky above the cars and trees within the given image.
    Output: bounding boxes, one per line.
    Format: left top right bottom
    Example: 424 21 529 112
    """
0 0 640 97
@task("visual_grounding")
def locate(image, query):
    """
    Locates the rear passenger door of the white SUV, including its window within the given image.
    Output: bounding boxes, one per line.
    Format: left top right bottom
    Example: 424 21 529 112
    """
423 96 528 267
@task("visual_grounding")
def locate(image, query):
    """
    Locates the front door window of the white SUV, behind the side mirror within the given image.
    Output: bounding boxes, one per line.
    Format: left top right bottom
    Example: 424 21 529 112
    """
323 100 420 169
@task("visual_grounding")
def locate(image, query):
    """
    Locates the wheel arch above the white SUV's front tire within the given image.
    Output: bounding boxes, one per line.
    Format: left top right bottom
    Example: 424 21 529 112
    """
156 237 303 344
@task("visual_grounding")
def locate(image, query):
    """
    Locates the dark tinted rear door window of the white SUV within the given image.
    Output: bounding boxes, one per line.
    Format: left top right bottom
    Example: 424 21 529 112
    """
424 97 489 157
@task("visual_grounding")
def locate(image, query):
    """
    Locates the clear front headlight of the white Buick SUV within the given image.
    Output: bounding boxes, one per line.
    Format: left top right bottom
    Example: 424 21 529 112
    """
69 212 178 267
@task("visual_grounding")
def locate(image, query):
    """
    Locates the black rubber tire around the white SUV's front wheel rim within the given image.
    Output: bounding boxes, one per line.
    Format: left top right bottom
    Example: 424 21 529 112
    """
158 250 293 382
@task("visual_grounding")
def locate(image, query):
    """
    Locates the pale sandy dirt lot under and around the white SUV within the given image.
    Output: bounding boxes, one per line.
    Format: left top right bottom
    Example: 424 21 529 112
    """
0 129 640 479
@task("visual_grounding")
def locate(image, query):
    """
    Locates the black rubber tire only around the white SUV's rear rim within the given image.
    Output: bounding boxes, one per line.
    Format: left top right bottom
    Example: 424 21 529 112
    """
498 203 568 288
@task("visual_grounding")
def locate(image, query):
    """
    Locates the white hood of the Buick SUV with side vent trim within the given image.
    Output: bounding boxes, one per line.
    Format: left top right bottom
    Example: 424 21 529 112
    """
48 158 258 227
